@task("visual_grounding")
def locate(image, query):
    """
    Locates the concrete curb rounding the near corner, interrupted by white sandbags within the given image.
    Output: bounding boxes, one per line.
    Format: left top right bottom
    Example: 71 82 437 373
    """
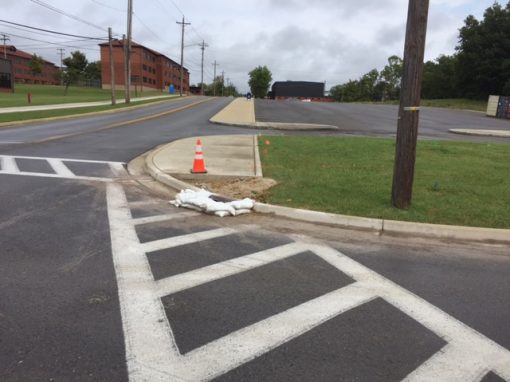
141 136 510 245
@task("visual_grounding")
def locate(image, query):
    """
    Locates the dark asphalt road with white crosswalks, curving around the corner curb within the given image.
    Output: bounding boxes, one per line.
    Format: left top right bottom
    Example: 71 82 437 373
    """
0 99 510 382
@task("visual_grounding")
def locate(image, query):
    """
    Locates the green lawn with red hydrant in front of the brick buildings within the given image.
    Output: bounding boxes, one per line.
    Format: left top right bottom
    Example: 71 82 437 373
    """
0 84 167 107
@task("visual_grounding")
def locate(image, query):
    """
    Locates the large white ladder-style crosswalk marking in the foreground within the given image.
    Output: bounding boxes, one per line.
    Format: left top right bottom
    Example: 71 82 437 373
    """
107 183 510 382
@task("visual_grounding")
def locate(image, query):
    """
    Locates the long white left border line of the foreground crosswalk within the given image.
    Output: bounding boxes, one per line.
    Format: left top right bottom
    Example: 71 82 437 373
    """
106 183 180 382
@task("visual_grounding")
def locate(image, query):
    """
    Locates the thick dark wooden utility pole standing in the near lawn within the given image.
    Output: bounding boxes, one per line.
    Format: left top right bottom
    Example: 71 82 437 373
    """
391 0 429 208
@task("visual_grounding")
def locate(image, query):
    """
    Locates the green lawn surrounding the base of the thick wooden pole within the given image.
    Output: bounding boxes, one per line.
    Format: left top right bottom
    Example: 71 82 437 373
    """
259 136 510 228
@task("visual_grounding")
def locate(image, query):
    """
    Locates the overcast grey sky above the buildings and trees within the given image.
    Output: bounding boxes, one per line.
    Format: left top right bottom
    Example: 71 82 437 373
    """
0 0 500 91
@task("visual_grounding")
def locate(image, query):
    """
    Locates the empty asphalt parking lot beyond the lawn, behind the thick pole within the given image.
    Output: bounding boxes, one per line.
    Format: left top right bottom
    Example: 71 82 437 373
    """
255 100 510 143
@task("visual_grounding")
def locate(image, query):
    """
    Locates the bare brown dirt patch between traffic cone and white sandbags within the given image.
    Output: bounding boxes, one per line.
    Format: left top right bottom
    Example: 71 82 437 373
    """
187 178 276 202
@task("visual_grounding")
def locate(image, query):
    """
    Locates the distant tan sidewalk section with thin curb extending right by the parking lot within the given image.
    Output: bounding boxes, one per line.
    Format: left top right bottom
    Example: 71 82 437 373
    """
209 98 338 130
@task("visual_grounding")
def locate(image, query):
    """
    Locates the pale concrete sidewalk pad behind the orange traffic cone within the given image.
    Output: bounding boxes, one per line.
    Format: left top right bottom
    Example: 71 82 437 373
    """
152 135 262 177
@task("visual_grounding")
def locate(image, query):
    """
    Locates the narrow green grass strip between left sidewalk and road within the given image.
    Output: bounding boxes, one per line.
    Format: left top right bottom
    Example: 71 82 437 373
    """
0 97 179 123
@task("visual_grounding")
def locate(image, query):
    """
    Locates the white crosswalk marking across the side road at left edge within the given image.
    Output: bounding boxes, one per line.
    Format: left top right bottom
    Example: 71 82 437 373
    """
0 155 127 182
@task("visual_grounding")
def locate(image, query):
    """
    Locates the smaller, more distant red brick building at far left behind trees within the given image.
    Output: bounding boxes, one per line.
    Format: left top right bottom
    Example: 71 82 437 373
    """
2 45 60 85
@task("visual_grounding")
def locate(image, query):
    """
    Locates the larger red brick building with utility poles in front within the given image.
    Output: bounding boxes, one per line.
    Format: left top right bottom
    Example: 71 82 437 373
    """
99 40 189 93
